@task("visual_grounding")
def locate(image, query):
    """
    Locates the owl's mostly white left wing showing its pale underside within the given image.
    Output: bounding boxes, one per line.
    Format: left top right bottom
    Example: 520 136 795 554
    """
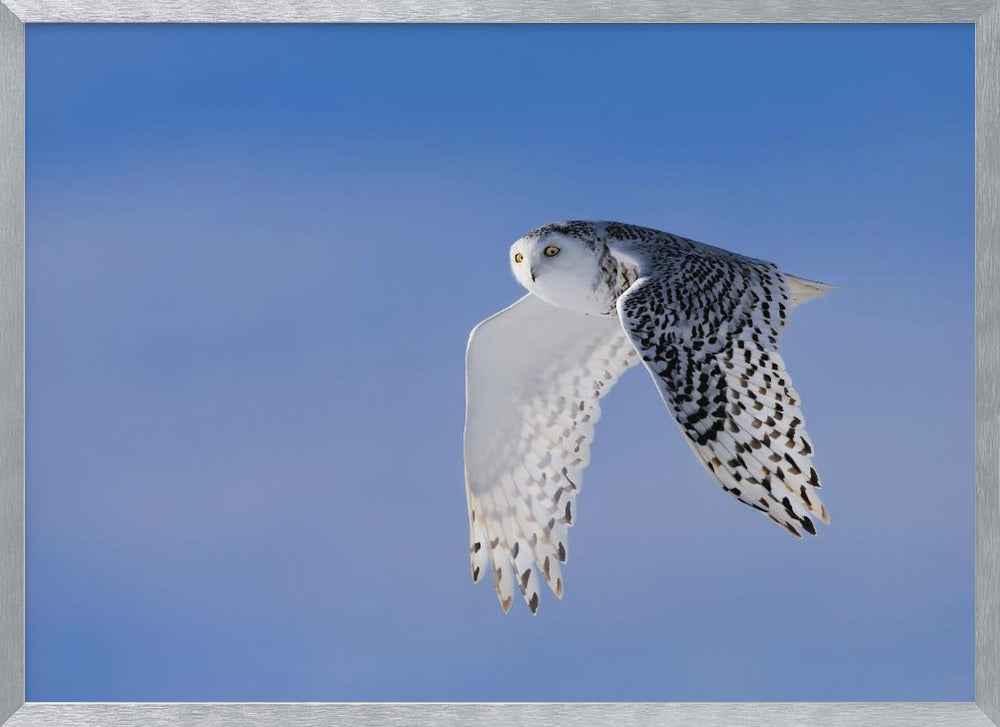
465 294 638 613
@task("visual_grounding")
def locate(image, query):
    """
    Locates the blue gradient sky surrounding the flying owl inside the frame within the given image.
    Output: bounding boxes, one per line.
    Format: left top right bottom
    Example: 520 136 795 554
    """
27 25 973 701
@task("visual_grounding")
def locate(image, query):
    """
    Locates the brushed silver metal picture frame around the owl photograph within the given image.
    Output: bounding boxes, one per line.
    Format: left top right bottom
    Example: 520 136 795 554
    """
0 0 1000 727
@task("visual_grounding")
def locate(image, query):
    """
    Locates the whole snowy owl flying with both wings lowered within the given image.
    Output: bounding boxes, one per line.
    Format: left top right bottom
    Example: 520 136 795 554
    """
465 221 833 613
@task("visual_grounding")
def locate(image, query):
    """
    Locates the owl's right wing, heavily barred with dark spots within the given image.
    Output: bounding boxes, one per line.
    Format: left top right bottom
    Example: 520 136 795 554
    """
618 246 829 536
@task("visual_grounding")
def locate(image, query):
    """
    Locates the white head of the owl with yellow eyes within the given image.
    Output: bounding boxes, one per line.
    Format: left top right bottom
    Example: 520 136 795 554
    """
510 221 608 313
